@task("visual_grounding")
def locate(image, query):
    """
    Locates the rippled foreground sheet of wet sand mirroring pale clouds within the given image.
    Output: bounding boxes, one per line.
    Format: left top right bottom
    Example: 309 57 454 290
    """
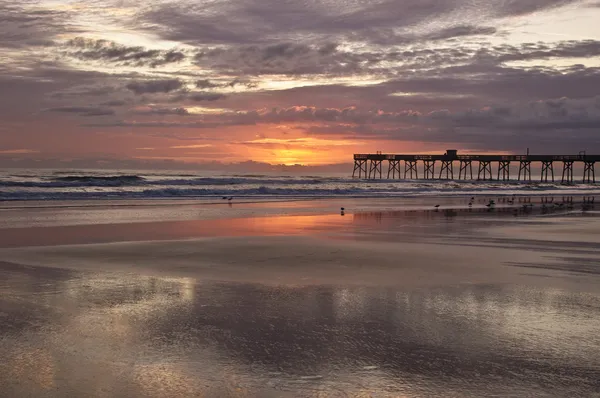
0 265 600 397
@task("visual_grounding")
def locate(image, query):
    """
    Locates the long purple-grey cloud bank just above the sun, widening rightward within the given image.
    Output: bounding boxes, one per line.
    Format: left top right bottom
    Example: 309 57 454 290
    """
88 96 600 154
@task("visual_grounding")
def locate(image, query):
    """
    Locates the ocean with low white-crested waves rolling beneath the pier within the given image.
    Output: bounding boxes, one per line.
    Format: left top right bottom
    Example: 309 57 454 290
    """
0 169 600 201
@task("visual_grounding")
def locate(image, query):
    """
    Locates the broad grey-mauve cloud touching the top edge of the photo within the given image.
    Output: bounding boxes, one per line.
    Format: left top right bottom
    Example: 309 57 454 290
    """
142 0 580 45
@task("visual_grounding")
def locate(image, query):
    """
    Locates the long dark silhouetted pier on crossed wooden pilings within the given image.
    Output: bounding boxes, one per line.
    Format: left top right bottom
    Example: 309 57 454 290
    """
352 149 600 184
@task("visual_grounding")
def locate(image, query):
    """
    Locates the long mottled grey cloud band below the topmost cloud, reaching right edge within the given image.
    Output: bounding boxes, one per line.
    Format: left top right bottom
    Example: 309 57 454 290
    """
188 38 600 79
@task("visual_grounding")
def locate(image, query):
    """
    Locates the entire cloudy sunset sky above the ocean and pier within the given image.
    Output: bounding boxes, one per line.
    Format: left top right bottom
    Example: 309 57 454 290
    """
0 0 600 168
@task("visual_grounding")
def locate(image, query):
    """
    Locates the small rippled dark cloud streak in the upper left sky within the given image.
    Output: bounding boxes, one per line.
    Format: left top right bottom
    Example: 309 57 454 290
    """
65 37 186 68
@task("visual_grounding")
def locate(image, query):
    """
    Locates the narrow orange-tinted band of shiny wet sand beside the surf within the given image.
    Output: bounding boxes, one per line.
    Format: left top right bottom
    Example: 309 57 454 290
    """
0 197 597 248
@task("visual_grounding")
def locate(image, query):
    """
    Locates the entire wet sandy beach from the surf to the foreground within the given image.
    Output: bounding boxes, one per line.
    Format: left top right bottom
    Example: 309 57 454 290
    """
0 198 600 397
